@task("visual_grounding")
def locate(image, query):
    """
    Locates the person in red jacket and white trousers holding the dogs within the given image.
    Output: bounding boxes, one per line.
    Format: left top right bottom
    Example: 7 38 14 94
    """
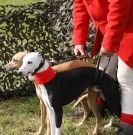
73 0 133 135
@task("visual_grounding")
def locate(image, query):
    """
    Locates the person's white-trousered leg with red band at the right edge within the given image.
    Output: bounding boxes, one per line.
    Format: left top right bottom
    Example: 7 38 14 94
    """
117 58 133 135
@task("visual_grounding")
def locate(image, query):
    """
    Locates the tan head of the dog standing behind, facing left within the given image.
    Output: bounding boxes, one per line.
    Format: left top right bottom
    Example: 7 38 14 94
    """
3 51 28 71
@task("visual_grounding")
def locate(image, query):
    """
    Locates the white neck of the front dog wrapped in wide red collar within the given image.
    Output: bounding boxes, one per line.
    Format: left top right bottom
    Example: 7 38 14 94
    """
34 61 56 84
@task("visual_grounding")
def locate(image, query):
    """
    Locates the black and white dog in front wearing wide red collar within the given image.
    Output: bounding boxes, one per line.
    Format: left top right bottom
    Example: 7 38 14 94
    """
18 52 121 135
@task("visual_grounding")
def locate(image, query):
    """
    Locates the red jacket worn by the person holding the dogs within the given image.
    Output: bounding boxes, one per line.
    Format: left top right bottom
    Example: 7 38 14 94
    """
73 0 133 68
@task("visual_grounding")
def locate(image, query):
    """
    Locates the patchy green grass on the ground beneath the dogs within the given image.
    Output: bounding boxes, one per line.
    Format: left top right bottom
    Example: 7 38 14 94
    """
0 96 116 135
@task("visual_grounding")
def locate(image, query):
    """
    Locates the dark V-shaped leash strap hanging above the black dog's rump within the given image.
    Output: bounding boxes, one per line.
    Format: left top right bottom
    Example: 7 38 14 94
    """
95 55 111 80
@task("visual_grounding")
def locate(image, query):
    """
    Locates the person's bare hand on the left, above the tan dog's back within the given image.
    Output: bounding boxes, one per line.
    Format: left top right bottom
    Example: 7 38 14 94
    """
74 45 85 55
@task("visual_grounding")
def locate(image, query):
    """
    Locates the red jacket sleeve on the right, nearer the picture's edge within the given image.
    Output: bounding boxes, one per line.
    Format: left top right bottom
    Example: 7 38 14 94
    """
102 0 131 52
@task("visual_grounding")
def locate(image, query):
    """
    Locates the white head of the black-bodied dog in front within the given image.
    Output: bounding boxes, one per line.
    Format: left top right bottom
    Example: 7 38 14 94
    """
18 52 46 76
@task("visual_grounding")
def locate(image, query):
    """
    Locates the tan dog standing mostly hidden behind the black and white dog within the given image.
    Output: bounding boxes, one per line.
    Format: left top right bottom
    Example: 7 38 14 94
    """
4 51 116 135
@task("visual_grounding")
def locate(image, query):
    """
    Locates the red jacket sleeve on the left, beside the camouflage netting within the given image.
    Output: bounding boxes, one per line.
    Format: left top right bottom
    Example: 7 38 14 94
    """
73 0 90 45
